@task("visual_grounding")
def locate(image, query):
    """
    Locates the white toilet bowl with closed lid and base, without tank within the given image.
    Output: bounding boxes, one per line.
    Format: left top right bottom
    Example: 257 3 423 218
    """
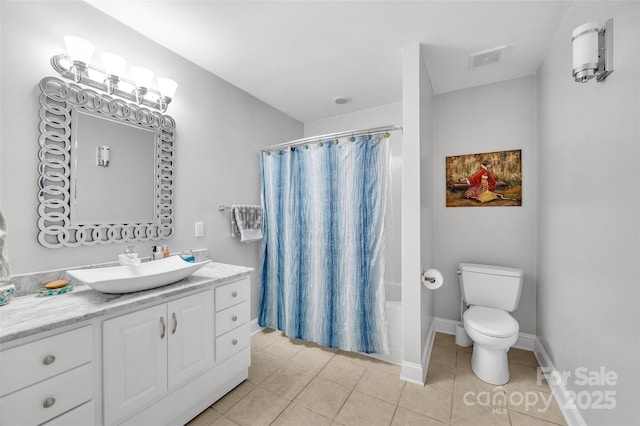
463 306 520 385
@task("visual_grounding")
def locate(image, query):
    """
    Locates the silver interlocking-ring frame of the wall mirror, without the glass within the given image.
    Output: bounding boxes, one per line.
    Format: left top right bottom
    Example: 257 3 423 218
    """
38 77 175 248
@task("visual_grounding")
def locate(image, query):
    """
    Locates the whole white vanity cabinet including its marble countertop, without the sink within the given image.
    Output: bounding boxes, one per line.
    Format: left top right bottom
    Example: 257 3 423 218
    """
0 263 252 426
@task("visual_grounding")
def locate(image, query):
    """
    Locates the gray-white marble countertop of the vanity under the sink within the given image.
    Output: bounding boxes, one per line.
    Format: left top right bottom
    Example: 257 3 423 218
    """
0 263 253 344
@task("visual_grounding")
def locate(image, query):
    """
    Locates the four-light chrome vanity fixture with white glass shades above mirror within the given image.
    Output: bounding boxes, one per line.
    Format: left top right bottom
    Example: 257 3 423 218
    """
51 36 178 113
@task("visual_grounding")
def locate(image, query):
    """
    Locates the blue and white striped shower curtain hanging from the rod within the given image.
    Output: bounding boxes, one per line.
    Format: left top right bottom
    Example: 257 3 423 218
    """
258 135 389 353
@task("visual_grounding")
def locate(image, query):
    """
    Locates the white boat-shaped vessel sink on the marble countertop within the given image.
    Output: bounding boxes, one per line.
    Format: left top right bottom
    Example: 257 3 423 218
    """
67 256 211 294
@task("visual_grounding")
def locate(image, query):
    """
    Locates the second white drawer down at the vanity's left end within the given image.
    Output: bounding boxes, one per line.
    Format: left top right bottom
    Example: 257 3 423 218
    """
0 364 93 425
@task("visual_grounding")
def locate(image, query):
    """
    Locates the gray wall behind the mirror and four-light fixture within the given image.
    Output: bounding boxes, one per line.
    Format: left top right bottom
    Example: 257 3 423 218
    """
0 1 303 318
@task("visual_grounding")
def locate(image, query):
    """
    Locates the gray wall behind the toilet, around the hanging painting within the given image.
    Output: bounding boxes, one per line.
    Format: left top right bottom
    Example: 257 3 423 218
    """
433 76 537 334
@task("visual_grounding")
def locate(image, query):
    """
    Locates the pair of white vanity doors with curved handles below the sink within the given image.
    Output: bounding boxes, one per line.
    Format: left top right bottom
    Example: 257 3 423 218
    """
103 290 214 425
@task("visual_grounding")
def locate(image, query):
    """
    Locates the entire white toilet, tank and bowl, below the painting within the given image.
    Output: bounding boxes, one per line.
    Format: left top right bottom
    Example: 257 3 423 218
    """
459 263 523 385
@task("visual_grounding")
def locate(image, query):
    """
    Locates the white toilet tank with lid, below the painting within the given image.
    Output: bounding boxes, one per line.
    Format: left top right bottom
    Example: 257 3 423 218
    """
458 263 524 312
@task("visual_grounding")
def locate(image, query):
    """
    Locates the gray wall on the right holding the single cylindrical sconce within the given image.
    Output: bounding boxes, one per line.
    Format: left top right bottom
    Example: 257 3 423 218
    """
537 2 640 425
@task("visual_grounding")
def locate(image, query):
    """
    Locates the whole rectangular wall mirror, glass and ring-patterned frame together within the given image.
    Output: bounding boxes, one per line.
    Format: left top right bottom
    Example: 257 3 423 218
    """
38 77 175 248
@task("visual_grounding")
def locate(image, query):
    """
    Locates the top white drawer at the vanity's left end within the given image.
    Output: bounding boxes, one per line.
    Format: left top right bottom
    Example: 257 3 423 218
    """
0 326 92 396
